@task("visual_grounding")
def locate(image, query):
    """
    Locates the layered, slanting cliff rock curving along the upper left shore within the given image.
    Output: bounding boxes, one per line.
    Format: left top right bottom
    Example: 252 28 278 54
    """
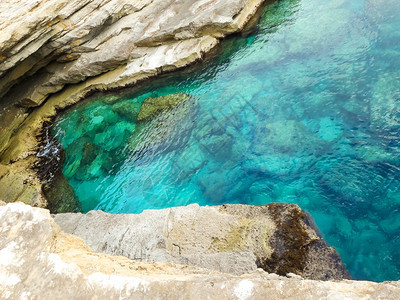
0 0 264 207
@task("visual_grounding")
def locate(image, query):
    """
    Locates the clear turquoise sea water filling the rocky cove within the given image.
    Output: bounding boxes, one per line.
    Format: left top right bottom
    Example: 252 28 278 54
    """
53 0 400 281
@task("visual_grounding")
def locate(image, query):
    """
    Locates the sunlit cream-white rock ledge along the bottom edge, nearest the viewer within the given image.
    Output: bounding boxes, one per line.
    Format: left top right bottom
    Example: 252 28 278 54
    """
0 202 400 300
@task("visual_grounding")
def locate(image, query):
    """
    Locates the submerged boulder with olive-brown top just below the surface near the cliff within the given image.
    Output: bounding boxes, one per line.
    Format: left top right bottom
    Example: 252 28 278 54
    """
129 93 197 159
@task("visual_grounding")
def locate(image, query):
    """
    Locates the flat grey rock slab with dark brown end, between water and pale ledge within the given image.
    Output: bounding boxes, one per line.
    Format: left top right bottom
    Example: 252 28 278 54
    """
55 203 350 280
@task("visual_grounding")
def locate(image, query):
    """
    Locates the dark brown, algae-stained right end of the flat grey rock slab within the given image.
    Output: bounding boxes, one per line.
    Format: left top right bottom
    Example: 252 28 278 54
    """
253 204 350 280
